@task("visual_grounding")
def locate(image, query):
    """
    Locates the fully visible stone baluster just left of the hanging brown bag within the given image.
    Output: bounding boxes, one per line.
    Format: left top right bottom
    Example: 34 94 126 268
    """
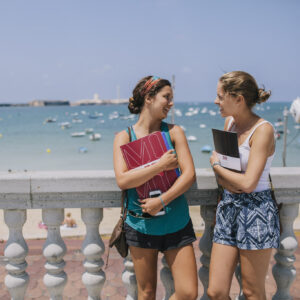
81 208 105 300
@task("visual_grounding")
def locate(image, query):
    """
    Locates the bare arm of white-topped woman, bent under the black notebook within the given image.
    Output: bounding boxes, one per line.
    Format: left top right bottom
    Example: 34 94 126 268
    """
210 124 274 193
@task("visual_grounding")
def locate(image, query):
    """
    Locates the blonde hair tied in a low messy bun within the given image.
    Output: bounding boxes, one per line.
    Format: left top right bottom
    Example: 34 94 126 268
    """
219 71 271 108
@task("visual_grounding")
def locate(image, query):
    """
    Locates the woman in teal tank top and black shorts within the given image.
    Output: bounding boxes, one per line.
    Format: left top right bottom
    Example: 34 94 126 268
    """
114 76 198 300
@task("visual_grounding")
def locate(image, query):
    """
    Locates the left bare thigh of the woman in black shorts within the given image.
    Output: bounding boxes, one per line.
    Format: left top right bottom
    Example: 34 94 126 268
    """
129 246 158 290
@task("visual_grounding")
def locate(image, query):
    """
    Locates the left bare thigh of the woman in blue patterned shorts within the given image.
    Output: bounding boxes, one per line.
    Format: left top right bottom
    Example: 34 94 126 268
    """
209 243 239 294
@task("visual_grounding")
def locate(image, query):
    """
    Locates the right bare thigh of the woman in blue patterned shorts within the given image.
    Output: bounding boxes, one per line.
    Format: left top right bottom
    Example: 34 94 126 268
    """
240 249 272 295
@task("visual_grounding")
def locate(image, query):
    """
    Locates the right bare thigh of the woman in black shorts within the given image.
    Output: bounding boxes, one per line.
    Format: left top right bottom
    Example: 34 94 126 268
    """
164 244 198 291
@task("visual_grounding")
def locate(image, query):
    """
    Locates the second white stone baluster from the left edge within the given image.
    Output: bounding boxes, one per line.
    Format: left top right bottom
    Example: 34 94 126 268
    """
42 208 67 300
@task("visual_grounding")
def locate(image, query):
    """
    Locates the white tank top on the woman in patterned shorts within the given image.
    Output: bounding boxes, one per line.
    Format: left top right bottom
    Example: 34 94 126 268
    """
227 118 275 192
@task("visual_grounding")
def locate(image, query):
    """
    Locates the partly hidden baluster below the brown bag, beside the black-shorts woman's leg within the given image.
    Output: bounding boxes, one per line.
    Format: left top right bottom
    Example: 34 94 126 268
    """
122 252 138 300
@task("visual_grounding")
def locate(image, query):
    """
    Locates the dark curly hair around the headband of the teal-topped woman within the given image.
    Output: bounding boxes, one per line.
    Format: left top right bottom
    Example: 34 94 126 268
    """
128 76 171 114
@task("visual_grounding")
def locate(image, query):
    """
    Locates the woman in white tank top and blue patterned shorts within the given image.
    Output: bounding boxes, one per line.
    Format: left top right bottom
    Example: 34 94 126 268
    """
207 71 280 300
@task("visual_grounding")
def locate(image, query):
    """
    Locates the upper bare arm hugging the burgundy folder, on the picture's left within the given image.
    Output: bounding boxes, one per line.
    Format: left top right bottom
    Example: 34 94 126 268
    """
113 131 177 190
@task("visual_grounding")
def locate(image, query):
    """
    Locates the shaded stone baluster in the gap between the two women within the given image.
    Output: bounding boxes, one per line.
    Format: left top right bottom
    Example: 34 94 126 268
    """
198 205 216 300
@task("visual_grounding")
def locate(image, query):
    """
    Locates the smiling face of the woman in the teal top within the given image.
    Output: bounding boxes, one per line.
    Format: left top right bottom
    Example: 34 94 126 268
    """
151 86 174 119
